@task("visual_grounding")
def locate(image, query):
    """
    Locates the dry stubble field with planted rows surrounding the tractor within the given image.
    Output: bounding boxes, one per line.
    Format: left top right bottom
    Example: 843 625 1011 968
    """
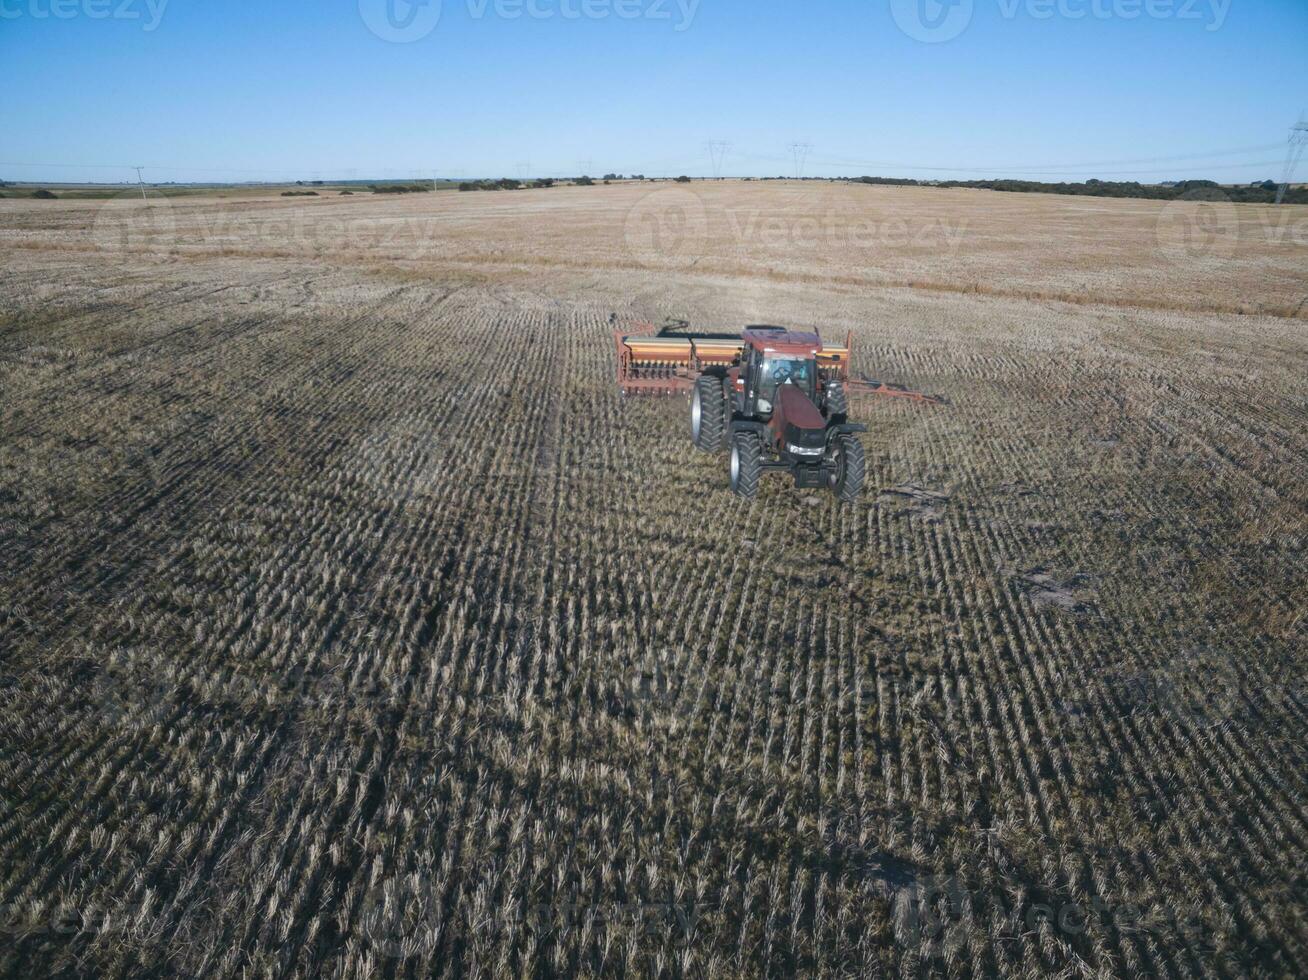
0 182 1308 977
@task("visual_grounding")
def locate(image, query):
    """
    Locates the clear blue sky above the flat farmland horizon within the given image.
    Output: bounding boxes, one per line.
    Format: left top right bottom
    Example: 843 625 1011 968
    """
0 0 1308 181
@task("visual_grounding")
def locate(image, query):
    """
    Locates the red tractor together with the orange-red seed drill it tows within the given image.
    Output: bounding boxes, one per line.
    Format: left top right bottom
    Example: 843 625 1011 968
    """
613 322 940 502
